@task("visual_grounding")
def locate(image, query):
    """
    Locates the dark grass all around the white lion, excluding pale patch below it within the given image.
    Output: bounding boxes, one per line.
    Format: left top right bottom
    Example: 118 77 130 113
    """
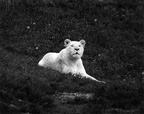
0 0 144 114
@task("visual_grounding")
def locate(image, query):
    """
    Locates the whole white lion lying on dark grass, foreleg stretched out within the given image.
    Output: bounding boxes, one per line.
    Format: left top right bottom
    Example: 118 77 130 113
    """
38 39 104 83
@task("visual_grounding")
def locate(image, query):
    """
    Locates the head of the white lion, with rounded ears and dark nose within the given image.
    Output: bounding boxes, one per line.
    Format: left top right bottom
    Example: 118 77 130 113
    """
64 39 86 59
